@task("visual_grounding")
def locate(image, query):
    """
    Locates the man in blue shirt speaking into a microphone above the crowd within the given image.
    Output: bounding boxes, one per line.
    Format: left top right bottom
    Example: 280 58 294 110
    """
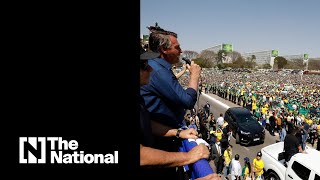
140 29 201 128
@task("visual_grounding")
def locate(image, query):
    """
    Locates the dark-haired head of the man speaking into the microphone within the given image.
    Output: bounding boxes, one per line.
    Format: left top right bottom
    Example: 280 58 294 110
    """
149 27 182 64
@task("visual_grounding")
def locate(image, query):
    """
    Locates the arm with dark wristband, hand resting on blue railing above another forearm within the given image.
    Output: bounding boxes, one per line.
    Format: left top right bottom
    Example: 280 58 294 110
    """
151 121 198 139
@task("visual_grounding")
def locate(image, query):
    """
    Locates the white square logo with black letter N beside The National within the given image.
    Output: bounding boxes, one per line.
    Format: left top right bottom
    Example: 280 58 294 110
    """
19 137 46 164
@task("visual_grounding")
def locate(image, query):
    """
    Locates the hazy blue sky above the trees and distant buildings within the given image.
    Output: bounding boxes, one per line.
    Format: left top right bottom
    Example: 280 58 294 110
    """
140 0 320 58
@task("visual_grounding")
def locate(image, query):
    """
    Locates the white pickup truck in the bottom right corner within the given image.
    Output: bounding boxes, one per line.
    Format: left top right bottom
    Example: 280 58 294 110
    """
261 142 320 180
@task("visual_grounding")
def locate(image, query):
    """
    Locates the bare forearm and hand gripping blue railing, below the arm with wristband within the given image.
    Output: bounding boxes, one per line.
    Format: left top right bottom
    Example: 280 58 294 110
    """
140 144 209 167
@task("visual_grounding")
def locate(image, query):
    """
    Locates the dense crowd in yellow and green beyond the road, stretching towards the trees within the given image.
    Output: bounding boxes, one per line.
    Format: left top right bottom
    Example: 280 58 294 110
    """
179 69 320 150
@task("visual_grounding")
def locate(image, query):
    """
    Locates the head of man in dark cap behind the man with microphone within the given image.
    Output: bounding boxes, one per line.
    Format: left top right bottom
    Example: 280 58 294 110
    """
139 49 160 86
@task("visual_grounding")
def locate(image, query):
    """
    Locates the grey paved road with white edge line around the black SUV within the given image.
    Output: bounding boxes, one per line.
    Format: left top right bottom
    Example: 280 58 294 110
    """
196 93 279 179
